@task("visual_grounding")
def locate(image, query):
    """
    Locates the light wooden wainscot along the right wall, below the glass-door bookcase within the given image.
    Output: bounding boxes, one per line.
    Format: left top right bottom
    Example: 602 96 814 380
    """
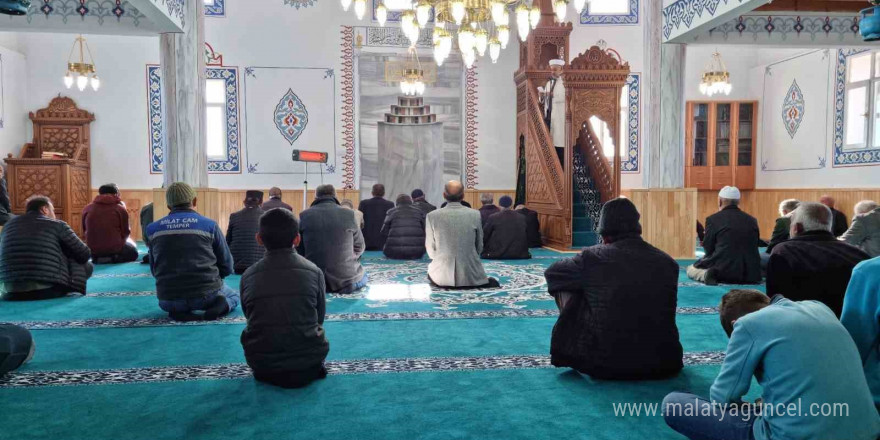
697 188 880 239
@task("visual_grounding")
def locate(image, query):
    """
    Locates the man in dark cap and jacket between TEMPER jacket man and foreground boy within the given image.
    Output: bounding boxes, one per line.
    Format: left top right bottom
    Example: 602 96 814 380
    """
226 191 266 274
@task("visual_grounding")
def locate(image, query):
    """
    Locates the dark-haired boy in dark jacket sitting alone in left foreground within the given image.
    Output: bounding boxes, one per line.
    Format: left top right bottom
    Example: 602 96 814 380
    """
241 208 330 388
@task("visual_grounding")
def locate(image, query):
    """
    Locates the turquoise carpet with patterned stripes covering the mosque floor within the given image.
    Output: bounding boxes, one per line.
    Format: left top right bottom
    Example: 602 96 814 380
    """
0 246 762 439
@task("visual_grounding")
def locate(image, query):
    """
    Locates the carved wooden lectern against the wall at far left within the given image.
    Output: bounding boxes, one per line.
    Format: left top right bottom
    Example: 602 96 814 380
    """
5 95 95 236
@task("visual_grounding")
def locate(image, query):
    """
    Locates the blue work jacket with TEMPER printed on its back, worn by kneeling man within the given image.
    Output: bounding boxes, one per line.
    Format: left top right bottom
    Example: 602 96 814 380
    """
147 209 233 300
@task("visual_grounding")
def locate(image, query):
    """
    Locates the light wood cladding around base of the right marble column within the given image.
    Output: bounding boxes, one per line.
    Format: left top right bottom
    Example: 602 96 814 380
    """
628 188 697 258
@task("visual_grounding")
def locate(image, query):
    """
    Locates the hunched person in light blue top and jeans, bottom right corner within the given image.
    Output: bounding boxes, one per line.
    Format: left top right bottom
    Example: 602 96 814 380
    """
663 290 880 440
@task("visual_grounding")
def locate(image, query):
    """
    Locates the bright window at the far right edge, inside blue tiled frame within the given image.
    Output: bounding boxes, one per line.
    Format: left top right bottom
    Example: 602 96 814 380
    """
844 52 880 150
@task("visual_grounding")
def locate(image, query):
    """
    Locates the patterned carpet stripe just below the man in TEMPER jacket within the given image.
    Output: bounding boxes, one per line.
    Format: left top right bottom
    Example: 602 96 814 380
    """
12 307 718 330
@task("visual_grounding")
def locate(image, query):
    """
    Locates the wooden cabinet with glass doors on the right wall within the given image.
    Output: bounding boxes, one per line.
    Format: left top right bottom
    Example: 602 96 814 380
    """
685 101 758 190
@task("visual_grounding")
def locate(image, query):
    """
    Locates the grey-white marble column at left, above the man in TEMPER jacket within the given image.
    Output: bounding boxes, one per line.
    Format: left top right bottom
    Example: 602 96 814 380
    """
159 1 208 188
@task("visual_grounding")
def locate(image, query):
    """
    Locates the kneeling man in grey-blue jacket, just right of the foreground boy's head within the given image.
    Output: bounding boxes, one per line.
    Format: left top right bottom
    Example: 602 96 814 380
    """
299 185 367 295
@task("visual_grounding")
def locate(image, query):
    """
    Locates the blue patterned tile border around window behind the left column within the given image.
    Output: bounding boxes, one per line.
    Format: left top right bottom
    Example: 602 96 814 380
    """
147 65 241 174
